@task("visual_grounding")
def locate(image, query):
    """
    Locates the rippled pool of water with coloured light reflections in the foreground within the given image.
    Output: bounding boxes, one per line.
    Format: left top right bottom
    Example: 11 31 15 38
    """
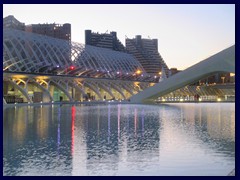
3 103 235 176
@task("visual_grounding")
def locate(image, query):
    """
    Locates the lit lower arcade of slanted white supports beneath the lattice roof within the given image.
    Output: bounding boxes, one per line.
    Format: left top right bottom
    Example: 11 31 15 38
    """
3 72 150 104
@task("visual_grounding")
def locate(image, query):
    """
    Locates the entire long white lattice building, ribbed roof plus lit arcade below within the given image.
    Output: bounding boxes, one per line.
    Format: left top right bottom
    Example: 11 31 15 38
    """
3 29 154 103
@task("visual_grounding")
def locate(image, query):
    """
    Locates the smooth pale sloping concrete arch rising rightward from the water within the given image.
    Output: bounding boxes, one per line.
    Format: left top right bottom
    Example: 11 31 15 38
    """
130 45 235 103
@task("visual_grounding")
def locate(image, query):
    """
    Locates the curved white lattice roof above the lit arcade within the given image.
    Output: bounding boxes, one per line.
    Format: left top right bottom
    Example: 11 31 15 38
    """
3 29 147 80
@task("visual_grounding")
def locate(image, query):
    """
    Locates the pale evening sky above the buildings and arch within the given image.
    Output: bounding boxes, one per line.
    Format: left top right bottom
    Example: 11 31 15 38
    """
3 4 235 69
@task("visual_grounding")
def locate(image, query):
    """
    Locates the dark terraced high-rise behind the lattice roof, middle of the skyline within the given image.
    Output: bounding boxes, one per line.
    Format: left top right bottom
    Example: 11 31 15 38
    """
85 30 125 52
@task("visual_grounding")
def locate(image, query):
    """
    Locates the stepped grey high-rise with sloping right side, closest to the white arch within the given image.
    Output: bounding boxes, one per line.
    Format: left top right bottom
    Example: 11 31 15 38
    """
126 35 169 76
